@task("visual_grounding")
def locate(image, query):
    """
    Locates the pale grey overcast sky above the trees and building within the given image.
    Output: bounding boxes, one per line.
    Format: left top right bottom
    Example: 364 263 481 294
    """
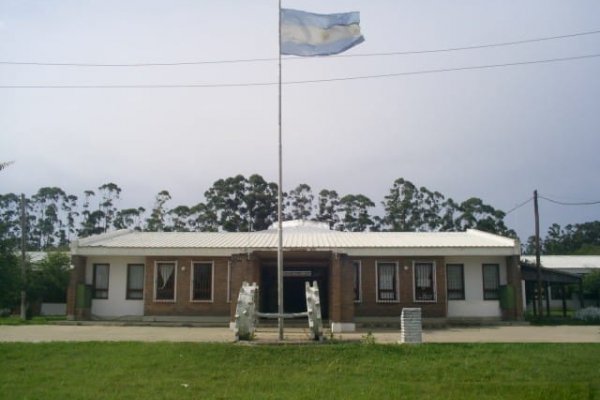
0 0 600 240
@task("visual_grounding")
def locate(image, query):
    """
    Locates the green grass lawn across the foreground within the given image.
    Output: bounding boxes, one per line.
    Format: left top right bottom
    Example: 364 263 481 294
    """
0 342 600 400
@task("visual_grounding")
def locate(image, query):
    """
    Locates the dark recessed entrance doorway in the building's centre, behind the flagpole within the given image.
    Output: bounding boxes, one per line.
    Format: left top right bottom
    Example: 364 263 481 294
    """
259 265 329 319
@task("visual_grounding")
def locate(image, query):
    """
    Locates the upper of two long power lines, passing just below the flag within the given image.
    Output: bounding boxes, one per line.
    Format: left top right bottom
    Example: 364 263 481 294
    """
0 30 600 68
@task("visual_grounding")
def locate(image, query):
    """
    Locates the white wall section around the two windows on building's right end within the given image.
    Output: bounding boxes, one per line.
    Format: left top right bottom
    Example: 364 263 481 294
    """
444 257 506 318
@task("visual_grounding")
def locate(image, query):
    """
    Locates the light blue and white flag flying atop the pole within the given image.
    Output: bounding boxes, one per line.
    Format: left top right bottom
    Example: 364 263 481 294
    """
281 9 365 57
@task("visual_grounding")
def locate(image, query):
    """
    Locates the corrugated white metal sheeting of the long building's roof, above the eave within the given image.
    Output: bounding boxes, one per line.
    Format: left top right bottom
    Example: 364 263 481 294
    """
73 226 518 249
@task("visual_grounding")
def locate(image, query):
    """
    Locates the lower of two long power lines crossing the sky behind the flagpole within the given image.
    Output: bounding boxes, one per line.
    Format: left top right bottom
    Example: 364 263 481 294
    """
0 53 600 89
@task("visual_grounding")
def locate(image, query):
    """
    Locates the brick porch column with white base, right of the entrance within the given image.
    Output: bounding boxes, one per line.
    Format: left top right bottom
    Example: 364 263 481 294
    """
329 253 356 333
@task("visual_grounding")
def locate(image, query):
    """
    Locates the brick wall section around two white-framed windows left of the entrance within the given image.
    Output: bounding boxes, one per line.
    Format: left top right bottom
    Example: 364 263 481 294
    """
144 257 230 316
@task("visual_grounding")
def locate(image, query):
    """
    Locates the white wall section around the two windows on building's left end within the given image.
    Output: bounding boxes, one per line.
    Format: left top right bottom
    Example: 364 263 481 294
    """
85 256 145 318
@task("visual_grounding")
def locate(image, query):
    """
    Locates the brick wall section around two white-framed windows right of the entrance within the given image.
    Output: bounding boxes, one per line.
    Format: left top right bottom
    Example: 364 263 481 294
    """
349 257 447 318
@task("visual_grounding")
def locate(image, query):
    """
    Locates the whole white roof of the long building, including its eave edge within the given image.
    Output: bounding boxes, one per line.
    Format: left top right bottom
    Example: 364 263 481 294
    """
71 221 520 256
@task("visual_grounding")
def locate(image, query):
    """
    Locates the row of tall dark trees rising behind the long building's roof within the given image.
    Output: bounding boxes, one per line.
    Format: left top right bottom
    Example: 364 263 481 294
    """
0 174 516 250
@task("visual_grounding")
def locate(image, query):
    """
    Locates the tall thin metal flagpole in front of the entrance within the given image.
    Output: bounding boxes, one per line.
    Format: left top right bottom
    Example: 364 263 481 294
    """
277 0 283 340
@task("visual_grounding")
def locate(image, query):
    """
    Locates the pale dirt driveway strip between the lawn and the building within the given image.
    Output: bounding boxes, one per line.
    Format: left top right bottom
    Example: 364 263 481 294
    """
0 325 600 343
